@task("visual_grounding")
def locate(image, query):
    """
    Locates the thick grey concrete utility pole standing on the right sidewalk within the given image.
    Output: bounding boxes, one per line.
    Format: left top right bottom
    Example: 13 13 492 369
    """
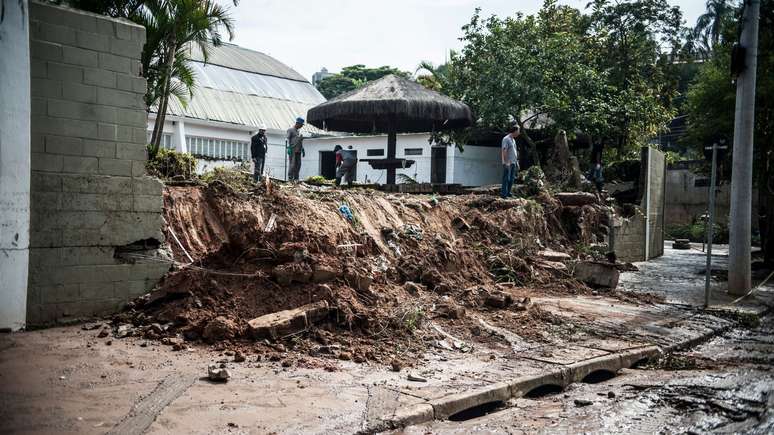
728 0 760 295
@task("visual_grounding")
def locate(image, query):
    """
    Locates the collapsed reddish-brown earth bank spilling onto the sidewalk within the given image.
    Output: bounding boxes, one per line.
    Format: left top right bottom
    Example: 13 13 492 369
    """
121 184 620 363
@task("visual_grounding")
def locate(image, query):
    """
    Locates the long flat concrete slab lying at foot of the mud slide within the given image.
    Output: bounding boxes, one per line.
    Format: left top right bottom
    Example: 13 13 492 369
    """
247 301 331 339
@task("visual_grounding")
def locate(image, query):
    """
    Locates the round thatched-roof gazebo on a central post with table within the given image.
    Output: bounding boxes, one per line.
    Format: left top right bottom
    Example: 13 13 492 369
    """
307 74 473 184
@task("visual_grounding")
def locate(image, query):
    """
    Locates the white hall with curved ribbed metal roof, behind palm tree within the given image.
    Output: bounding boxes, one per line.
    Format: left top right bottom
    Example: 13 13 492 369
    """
148 44 325 178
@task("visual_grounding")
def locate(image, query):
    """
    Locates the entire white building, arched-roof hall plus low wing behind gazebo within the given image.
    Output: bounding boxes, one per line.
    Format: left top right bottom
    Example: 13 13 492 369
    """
148 44 502 186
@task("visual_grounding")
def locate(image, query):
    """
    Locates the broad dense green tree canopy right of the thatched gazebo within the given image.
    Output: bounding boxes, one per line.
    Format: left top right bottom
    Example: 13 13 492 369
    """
441 0 681 159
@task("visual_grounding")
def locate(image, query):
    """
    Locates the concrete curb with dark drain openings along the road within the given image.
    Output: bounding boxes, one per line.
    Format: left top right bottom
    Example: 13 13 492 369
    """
368 307 771 435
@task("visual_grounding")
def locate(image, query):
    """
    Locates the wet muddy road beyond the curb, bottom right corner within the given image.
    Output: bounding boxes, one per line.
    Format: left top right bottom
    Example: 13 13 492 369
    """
396 316 774 434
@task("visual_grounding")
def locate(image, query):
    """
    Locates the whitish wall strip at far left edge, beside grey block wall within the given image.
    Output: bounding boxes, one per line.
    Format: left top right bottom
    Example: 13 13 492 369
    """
0 0 30 330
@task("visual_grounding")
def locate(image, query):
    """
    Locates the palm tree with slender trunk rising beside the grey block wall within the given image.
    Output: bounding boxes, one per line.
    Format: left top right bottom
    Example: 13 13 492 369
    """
145 0 234 155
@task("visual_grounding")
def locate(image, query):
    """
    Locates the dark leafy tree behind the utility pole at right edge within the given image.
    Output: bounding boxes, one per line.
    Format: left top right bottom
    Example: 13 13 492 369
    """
684 0 774 266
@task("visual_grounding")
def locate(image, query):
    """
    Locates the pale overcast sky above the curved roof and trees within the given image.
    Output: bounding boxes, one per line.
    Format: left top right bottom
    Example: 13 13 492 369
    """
219 0 705 80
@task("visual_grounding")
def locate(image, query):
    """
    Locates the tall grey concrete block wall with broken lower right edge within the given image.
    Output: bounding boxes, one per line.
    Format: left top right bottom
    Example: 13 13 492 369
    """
27 2 168 325
